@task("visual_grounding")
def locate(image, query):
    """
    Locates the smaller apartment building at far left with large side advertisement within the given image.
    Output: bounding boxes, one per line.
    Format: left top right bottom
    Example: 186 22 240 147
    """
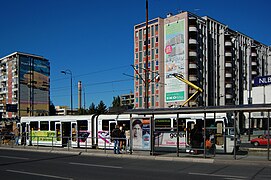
0 52 50 118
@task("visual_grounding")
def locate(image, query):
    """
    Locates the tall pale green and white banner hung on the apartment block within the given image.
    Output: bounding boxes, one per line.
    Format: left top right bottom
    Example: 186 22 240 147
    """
164 19 186 103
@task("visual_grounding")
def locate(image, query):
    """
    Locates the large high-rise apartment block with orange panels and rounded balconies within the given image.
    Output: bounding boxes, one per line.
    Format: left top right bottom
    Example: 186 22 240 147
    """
134 12 271 108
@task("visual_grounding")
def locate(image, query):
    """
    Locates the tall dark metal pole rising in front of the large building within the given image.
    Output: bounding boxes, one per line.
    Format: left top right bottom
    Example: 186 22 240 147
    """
145 0 149 109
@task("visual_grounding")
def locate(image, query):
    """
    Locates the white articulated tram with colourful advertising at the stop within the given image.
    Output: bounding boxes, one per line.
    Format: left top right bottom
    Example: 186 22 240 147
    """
18 113 240 153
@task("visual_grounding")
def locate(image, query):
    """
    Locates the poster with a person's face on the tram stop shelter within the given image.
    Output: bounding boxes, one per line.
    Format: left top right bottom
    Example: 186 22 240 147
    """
131 118 150 150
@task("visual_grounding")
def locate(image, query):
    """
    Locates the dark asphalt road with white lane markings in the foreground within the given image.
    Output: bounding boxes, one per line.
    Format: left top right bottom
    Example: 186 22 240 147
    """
0 150 271 180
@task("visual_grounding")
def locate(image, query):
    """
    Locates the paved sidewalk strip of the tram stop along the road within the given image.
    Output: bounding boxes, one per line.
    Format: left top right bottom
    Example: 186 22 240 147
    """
0 145 271 166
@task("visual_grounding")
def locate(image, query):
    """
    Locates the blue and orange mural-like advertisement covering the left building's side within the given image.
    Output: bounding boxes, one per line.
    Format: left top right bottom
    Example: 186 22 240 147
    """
19 56 50 116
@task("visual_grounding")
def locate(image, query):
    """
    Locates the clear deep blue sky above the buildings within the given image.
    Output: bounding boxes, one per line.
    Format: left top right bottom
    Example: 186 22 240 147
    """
0 0 271 108
